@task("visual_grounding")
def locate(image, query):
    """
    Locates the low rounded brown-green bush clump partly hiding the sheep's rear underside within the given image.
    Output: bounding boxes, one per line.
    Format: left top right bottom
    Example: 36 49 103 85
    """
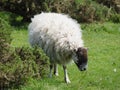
0 47 49 88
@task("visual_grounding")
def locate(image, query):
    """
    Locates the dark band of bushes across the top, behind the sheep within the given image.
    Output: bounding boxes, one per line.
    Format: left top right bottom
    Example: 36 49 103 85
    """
0 0 118 22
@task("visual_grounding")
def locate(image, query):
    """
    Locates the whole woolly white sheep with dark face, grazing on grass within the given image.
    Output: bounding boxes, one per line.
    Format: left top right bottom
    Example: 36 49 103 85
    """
28 12 88 83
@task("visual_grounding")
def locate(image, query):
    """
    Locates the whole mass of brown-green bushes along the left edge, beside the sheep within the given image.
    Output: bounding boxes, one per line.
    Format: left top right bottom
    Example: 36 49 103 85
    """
0 18 49 90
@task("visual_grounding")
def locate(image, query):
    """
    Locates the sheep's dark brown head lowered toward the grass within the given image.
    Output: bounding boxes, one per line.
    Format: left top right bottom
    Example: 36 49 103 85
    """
73 47 88 71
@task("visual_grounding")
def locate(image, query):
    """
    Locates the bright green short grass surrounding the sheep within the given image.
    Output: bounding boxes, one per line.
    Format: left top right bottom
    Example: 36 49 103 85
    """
11 22 120 90
